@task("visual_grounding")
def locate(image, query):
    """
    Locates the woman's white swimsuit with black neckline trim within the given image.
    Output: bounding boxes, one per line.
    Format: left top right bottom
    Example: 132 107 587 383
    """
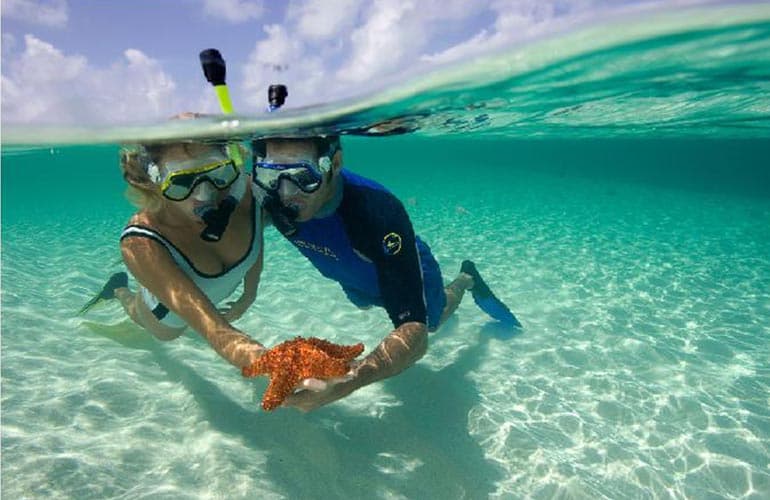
120 200 262 328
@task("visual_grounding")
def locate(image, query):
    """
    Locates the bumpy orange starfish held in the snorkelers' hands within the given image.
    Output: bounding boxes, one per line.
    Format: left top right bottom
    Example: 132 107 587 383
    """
241 337 364 411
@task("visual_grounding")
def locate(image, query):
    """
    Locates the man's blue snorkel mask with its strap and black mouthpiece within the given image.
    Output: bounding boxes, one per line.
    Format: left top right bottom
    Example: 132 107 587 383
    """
252 135 340 236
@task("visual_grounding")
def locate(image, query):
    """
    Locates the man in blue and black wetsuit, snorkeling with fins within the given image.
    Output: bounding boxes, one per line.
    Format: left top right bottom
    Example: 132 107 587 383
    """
252 136 521 411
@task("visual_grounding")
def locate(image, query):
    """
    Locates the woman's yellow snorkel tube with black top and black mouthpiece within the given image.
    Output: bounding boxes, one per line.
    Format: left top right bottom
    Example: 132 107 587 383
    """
199 49 246 241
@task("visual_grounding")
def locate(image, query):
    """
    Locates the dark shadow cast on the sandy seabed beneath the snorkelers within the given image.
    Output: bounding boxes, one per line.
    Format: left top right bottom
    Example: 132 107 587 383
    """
84 318 512 499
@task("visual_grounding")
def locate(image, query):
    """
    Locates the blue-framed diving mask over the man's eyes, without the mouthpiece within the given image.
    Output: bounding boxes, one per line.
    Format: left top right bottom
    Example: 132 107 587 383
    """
252 156 331 194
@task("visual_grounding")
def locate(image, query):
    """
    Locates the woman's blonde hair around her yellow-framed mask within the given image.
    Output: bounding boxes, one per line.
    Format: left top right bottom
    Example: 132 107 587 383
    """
120 142 236 212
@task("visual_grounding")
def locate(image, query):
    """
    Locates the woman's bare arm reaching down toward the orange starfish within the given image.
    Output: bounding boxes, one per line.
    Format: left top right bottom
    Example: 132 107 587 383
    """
121 234 264 367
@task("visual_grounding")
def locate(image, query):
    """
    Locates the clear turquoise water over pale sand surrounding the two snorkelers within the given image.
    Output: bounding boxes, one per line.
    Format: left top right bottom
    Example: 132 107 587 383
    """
0 6 770 499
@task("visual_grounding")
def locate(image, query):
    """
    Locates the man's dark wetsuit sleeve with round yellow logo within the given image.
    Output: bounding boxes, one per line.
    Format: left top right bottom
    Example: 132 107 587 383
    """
340 186 427 328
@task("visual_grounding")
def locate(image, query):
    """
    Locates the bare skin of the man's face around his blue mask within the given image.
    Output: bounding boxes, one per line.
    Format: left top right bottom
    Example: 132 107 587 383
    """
264 139 331 222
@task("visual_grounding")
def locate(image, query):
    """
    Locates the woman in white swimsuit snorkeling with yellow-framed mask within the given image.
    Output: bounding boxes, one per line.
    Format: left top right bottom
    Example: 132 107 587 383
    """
81 142 264 368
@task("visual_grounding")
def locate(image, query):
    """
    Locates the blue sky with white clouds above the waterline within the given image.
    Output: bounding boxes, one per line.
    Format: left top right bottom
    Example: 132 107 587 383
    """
2 0 714 123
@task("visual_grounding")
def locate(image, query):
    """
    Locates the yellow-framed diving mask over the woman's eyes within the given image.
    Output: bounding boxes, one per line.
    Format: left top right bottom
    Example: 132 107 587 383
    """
147 153 240 201
